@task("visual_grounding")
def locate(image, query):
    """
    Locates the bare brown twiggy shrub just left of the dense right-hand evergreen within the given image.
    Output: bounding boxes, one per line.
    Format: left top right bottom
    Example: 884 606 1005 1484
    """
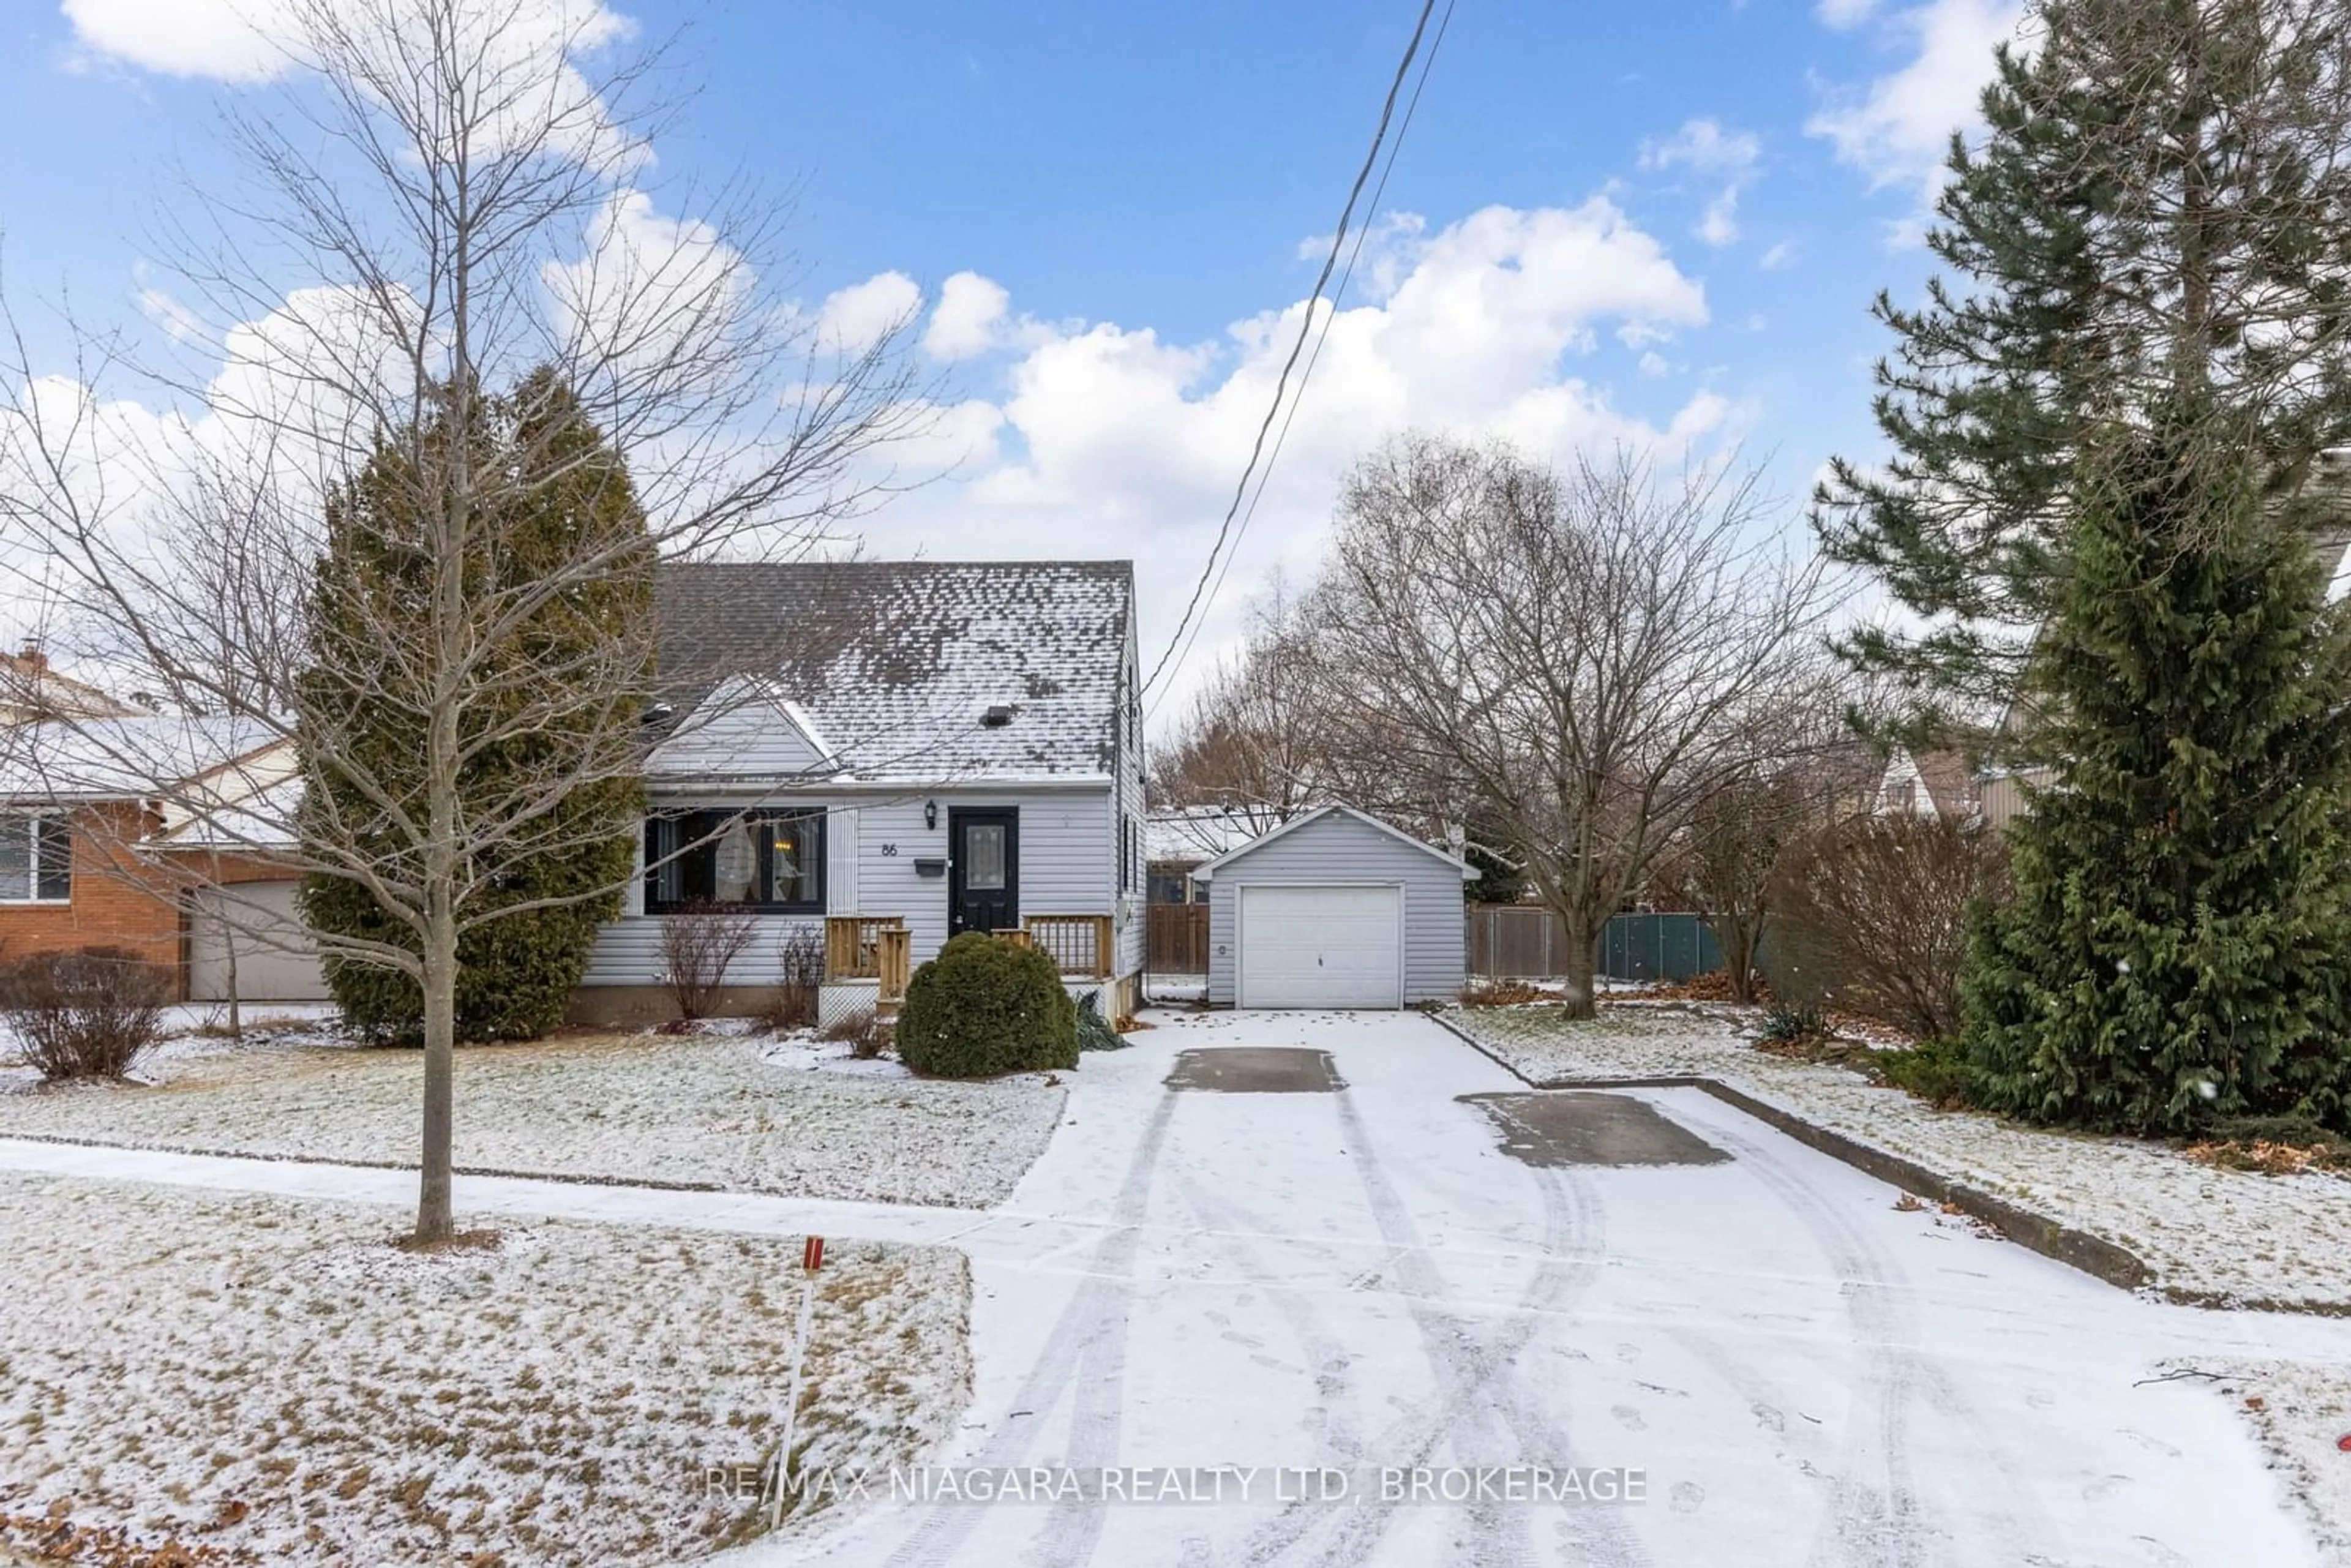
1768 816 2008 1039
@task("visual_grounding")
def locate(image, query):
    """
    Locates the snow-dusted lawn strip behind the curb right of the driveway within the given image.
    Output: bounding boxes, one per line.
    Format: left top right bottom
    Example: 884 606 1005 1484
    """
1446 1004 2351 1316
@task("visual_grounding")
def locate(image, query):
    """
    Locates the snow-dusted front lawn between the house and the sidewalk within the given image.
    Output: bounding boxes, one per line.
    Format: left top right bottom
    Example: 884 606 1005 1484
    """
0 1032 1065 1206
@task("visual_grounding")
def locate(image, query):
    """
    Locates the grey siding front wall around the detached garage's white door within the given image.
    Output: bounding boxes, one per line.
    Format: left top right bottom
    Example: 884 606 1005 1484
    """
1209 813 1467 1006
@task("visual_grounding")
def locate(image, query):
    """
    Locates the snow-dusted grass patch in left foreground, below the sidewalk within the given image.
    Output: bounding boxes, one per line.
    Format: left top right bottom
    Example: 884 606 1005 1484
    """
0 1176 971 1568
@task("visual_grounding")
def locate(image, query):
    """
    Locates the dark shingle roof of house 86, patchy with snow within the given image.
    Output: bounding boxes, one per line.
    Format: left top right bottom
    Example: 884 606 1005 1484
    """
656 562 1136 781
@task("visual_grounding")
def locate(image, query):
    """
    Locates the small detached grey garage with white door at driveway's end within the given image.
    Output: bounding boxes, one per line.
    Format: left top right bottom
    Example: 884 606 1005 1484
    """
1192 806 1477 1008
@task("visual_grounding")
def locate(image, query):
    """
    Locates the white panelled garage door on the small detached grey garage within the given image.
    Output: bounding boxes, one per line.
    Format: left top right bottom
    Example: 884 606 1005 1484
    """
1239 887 1403 1006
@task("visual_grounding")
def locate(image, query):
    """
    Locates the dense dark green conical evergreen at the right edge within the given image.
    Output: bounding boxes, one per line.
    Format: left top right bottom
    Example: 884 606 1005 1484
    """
1963 421 2351 1133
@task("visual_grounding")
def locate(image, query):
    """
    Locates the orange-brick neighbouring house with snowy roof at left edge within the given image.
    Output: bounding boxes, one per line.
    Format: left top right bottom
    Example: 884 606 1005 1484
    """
0 715 308 994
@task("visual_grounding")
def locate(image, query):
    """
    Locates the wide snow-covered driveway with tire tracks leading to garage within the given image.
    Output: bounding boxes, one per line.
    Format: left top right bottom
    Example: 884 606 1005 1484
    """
738 1013 2351 1568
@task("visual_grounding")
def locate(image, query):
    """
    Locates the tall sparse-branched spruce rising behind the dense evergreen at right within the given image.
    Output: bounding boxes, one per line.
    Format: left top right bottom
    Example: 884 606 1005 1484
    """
1815 0 2351 740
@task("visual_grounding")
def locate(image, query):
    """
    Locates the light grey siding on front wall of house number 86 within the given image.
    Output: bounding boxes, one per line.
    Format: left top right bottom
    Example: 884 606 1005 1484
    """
580 785 1117 985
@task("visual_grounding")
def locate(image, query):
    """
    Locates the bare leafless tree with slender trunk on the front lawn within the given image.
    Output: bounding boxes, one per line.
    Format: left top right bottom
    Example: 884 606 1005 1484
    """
0 0 926 1241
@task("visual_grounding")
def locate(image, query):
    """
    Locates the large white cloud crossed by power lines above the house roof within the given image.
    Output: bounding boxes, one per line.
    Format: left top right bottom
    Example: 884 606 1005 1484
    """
865 198 1740 710
